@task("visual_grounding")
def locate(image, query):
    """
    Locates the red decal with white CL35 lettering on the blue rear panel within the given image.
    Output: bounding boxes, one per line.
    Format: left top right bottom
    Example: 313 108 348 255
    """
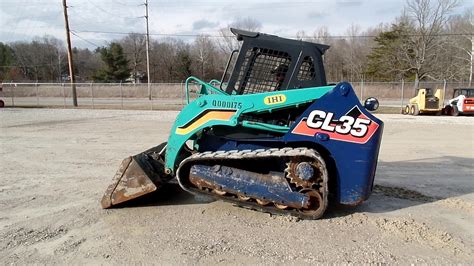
292 106 379 144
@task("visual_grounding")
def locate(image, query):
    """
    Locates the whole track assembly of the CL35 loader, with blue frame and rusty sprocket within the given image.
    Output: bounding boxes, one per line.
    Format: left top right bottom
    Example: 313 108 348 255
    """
176 147 328 219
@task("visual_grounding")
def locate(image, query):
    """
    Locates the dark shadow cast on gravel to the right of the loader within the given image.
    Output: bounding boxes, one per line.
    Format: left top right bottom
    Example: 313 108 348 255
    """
326 156 474 218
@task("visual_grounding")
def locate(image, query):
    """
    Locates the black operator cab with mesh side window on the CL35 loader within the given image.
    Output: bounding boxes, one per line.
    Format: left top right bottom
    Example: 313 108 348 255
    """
221 28 329 95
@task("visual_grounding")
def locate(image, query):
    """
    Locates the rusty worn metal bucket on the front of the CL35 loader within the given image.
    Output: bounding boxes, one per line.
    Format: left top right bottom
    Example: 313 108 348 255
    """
101 147 170 209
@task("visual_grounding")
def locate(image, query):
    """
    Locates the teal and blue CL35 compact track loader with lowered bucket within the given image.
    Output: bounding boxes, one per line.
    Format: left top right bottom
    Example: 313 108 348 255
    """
101 29 383 219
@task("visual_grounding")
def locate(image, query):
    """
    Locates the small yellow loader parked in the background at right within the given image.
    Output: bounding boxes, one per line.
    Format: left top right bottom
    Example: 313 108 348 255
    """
402 88 444 115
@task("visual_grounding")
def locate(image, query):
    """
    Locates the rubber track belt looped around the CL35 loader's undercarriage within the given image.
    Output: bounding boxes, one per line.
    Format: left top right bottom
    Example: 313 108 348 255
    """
176 147 328 219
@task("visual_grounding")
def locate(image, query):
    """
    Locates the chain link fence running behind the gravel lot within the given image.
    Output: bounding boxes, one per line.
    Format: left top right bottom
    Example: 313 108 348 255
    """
0 81 467 110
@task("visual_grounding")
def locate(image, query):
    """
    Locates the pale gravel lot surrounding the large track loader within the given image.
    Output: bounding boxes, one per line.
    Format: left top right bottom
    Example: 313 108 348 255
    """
0 109 474 264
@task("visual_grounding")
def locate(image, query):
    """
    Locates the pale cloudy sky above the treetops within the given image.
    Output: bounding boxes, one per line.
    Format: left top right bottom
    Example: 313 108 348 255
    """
0 0 474 48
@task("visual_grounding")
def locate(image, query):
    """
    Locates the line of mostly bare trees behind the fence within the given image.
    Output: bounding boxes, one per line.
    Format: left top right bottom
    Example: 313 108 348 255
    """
0 0 474 86
